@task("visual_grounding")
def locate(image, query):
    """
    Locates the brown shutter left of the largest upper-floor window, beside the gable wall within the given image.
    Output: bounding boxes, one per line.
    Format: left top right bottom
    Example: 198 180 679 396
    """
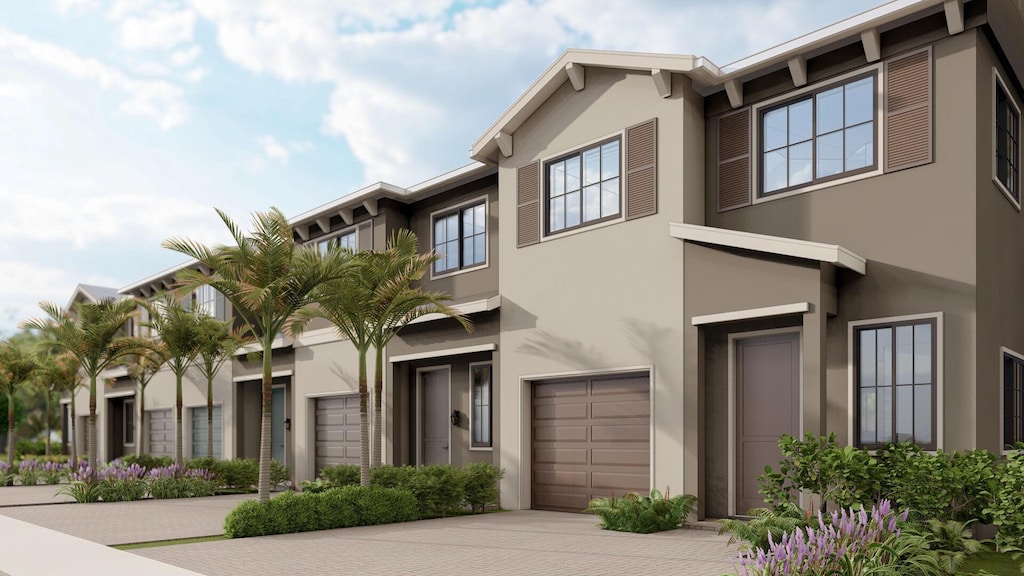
718 108 751 212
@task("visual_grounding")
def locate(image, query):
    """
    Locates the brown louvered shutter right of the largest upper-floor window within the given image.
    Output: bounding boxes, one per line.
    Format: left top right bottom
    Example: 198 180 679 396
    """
884 46 932 172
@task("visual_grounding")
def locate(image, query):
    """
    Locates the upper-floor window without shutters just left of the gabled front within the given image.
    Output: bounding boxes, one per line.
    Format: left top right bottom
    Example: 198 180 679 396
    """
433 200 487 274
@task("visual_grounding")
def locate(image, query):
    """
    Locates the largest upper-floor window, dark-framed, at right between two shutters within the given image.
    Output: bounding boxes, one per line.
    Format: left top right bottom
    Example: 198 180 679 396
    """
760 74 877 196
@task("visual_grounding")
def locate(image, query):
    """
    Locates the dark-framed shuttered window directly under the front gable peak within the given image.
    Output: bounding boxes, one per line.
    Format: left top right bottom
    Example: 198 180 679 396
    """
545 138 622 234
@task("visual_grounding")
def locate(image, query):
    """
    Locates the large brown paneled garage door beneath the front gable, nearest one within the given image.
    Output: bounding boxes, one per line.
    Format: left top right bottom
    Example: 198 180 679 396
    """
532 374 650 512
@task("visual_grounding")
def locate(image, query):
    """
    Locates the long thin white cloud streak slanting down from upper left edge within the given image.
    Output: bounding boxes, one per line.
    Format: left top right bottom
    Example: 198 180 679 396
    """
0 29 188 130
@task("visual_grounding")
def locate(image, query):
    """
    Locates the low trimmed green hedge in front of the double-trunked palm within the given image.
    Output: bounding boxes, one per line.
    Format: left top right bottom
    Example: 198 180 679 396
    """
224 486 419 538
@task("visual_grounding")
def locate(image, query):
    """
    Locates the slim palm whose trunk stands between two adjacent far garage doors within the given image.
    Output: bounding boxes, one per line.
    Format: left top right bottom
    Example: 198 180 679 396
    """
144 294 201 465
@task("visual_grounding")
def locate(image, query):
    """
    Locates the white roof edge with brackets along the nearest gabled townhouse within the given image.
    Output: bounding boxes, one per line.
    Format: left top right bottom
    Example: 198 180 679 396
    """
470 0 970 163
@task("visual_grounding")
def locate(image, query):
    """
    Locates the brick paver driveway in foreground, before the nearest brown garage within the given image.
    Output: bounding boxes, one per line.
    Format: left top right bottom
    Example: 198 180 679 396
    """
135 510 736 576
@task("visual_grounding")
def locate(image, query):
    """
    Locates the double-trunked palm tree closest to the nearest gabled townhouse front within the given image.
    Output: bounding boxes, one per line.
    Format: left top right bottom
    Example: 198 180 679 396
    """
289 230 471 486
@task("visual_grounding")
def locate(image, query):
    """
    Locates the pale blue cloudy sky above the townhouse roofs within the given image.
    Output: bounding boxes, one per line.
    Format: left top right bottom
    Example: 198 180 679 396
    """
0 0 885 336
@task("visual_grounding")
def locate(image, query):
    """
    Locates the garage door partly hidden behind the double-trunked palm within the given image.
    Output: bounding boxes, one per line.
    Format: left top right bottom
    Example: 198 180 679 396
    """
314 394 359 475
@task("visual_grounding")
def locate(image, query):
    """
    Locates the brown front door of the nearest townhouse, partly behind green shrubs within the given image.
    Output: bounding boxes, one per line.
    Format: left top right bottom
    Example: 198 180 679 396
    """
733 332 800 515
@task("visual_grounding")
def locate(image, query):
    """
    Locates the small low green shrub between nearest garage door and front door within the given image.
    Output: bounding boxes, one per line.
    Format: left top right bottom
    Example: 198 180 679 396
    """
586 490 697 534
